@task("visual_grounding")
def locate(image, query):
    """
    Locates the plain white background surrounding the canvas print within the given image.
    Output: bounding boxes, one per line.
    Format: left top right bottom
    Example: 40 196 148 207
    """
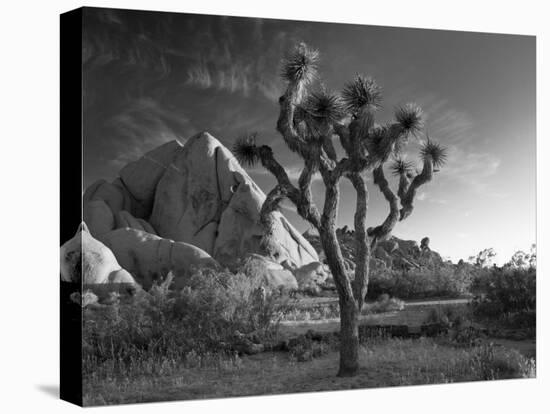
0 0 550 414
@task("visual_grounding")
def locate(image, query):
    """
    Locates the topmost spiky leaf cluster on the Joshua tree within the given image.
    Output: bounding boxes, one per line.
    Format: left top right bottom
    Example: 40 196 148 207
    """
281 43 319 85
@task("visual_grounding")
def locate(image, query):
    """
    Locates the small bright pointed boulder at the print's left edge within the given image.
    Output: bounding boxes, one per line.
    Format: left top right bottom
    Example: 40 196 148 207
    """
60 223 136 285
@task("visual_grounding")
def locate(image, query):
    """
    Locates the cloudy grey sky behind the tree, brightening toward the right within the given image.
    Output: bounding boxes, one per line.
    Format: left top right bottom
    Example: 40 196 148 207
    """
83 8 536 263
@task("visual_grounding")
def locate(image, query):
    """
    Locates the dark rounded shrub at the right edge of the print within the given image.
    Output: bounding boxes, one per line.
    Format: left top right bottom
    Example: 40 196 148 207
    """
472 267 536 327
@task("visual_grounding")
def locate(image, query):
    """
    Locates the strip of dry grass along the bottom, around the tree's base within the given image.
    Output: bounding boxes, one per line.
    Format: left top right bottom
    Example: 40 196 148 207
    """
84 338 535 405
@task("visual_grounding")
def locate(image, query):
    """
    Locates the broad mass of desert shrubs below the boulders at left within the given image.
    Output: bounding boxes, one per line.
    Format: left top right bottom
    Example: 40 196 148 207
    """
83 270 285 374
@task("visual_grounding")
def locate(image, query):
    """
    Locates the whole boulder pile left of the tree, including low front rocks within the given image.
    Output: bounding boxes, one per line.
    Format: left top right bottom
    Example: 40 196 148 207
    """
66 133 319 290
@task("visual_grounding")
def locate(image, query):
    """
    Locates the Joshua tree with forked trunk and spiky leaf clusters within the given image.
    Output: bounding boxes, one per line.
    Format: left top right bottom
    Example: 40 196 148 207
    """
233 44 446 376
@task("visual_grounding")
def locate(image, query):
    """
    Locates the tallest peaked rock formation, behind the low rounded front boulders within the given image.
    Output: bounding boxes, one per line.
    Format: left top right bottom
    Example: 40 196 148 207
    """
84 132 319 268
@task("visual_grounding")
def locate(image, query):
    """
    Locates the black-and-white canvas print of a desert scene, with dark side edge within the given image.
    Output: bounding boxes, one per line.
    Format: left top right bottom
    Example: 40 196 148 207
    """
61 8 537 405
